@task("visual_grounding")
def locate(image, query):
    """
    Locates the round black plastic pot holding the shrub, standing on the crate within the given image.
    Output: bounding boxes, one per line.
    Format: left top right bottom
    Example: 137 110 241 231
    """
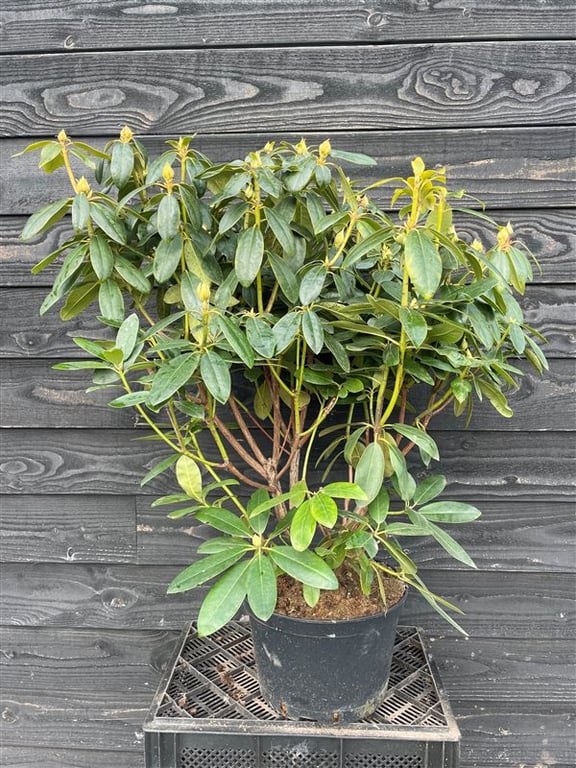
249 593 406 724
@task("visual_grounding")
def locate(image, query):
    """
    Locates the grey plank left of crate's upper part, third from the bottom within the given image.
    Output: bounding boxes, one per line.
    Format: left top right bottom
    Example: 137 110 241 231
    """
0 627 178 701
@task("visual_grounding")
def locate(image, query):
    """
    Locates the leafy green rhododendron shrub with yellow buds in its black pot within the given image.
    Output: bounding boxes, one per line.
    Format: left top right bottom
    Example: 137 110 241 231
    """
22 128 546 720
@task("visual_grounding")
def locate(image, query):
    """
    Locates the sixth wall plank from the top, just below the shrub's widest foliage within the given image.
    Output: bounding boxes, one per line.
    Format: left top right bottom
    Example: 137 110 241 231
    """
0 358 576 432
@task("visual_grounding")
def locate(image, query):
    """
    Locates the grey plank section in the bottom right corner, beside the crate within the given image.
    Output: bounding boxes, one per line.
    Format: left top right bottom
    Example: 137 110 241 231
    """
451 699 574 768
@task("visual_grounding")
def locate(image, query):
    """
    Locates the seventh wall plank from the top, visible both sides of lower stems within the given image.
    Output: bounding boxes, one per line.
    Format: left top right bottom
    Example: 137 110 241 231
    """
0 429 576 502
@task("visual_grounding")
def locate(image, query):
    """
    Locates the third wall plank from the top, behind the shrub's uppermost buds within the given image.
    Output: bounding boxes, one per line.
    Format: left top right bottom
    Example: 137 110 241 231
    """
0 127 576 214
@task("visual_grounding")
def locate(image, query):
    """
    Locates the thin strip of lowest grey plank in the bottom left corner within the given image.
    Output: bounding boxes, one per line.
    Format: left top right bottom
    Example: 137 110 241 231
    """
0 734 144 768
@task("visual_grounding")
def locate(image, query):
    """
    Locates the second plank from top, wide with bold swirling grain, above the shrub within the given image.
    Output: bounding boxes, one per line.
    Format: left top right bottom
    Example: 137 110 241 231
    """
0 40 576 136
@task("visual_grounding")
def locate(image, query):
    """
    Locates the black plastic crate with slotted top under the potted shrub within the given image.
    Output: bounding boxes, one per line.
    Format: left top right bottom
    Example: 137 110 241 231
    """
144 622 460 768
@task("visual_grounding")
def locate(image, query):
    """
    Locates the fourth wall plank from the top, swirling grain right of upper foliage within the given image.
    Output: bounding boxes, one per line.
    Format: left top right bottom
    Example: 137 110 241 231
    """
5 207 576 287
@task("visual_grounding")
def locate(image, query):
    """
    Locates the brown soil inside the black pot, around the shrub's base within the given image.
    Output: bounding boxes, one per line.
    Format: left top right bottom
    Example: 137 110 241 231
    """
276 569 406 620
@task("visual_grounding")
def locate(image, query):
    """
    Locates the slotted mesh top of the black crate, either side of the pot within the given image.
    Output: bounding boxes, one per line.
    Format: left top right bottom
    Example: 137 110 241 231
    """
157 622 447 728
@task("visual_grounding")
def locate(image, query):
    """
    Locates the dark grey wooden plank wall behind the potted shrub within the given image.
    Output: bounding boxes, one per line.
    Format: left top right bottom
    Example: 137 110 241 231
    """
0 0 576 768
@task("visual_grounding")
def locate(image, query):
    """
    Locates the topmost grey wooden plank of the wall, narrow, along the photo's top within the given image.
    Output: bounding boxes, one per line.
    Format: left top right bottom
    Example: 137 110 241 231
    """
0 0 571 53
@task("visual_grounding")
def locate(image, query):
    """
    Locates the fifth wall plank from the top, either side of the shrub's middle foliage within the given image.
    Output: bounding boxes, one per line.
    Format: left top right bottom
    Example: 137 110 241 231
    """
0 284 576 360
